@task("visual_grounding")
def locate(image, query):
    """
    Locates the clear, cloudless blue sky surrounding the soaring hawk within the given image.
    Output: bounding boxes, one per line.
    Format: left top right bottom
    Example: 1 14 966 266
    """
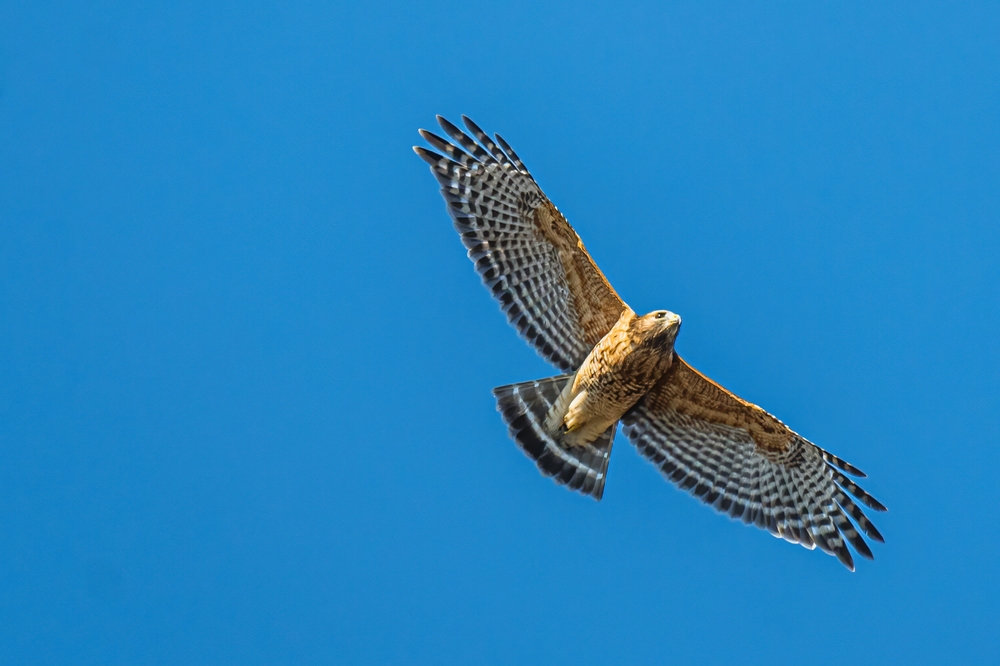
0 2 1000 664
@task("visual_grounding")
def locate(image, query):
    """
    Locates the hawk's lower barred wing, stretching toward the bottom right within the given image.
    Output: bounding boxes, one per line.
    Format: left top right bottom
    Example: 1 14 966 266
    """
622 355 885 571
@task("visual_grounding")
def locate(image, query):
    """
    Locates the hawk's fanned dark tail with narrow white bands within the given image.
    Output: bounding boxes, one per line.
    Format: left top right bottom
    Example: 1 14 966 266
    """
493 375 618 500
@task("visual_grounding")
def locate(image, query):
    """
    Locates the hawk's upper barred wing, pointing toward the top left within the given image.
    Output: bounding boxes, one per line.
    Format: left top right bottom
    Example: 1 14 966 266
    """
413 116 625 372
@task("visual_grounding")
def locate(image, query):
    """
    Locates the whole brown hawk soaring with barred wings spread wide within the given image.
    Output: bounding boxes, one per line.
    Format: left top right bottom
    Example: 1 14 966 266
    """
413 116 886 571
